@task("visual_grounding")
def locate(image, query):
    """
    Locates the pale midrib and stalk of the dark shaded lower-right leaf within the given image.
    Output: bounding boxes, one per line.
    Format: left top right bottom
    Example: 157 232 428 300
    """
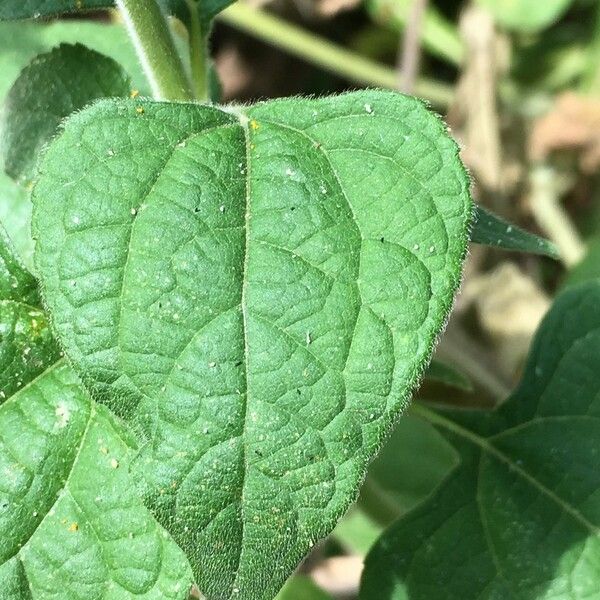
410 402 600 536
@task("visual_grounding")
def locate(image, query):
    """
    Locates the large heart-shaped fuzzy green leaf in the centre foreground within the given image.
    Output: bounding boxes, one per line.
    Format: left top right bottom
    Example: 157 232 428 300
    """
34 91 472 599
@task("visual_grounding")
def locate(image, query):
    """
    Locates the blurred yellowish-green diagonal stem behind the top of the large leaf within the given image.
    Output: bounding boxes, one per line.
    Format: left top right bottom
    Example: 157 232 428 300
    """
219 2 454 107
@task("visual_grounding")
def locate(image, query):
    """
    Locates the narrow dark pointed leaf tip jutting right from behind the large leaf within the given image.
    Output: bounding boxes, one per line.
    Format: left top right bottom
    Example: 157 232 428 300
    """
471 206 560 258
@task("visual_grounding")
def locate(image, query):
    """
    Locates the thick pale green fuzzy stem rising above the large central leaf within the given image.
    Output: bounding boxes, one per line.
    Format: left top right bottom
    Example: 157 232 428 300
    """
116 0 193 100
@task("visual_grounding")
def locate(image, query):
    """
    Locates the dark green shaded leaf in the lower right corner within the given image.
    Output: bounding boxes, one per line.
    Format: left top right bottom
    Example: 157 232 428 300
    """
361 282 600 600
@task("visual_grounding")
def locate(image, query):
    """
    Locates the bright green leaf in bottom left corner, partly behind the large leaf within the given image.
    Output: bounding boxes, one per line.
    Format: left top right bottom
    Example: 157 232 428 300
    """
0 363 192 600
